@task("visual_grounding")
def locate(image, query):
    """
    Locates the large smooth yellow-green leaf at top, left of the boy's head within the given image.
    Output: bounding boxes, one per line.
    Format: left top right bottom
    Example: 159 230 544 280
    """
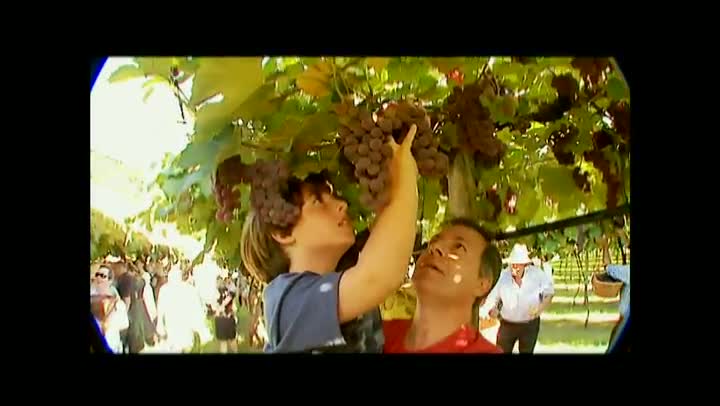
190 57 262 111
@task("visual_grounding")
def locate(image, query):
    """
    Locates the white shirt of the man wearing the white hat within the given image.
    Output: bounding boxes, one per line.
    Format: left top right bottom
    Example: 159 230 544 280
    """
479 265 555 323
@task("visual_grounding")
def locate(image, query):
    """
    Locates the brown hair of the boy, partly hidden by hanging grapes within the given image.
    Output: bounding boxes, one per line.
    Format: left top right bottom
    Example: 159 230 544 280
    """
240 173 340 283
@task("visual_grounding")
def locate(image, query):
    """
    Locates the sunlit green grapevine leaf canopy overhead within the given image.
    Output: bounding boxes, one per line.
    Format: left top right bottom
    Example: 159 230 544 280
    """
110 56 630 274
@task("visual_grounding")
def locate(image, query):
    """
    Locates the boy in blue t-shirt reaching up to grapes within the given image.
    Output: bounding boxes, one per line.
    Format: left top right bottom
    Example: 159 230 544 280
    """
241 125 418 353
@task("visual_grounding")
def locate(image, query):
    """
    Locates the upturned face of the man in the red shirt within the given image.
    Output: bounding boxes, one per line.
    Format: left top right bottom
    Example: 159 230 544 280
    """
412 225 490 301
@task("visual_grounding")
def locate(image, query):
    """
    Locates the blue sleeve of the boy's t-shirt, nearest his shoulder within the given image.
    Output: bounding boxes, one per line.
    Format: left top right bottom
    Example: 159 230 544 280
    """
265 272 346 352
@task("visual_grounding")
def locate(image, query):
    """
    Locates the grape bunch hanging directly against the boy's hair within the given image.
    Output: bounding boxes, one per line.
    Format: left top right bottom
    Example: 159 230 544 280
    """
247 160 300 228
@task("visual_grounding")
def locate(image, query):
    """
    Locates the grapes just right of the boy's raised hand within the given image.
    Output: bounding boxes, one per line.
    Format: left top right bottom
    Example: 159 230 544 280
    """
378 102 450 178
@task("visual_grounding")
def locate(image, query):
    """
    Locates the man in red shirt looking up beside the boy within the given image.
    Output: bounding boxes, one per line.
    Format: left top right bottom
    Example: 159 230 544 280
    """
383 219 502 354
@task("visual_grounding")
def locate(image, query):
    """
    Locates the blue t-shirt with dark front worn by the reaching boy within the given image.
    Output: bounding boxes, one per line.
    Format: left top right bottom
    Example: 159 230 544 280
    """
263 271 385 353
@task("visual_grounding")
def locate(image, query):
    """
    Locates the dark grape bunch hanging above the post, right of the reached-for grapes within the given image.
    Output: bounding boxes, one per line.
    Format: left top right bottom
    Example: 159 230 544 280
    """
445 80 506 168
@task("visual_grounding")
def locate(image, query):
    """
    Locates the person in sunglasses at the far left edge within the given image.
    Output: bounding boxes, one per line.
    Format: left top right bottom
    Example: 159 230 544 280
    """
90 282 129 354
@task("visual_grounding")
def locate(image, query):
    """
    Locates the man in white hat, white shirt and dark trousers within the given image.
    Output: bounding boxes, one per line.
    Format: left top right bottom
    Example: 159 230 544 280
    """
479 244 555 353
